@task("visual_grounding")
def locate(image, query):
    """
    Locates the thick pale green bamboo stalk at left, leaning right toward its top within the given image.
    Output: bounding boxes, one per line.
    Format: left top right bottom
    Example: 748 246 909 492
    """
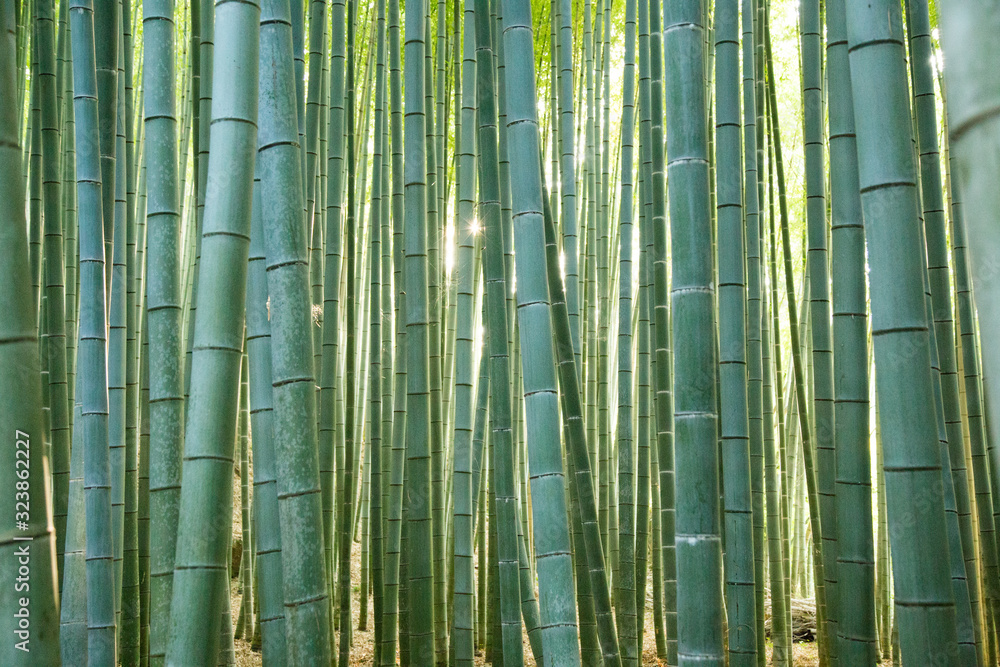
167 0 260 664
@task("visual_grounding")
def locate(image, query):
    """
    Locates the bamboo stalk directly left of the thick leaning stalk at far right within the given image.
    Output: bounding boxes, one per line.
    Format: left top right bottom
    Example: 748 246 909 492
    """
826 0 878 664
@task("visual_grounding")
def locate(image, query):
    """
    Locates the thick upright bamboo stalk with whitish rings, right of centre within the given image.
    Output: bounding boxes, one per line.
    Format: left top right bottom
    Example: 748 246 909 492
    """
654 2 724 665
